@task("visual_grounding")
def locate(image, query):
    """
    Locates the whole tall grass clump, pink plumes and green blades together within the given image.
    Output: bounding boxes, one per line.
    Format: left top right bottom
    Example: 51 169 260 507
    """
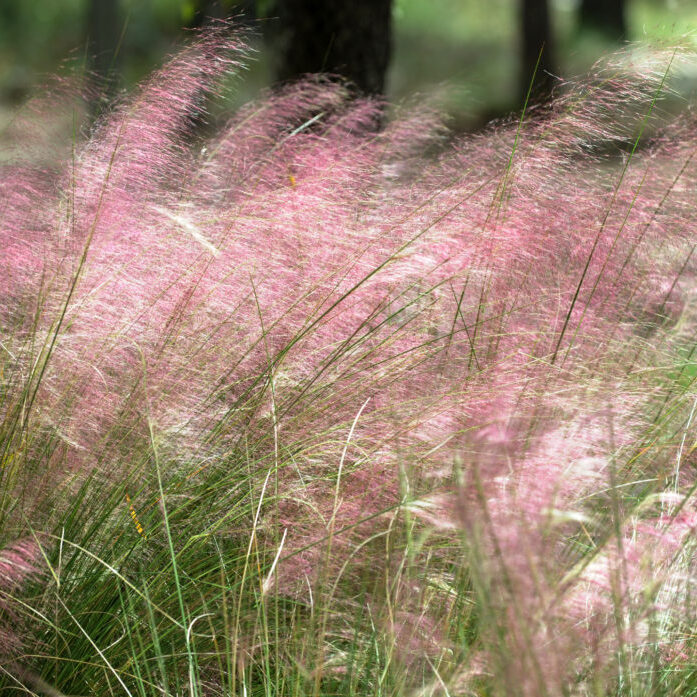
0 23 697 697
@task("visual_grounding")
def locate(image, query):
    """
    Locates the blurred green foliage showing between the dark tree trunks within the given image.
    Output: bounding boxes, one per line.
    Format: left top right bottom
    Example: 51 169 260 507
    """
0 0 697 130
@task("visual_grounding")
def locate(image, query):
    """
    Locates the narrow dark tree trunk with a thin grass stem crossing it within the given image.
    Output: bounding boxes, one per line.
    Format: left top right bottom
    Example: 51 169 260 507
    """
520 0 556 101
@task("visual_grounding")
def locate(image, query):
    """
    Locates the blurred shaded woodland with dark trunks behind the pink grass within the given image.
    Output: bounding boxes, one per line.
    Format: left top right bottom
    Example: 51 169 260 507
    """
0 0 697 131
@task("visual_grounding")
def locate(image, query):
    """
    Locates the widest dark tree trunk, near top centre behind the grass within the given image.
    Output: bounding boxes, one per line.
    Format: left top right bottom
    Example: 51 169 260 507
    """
274 0 392 94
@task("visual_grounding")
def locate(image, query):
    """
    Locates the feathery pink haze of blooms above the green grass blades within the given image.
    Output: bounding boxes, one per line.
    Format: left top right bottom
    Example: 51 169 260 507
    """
0 25 697 684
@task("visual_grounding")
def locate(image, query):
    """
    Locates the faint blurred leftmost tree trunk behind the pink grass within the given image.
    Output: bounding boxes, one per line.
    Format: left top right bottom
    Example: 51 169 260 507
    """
87 0 122 92
